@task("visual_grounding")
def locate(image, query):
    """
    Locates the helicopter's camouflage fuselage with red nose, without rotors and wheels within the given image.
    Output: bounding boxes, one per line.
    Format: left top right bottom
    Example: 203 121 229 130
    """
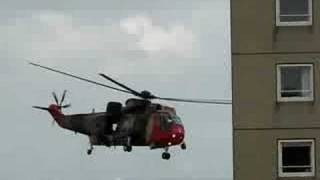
48 104 185 149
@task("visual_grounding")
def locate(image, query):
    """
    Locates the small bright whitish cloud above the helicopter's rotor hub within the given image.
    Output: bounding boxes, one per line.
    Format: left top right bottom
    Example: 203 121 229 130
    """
120 15 195 57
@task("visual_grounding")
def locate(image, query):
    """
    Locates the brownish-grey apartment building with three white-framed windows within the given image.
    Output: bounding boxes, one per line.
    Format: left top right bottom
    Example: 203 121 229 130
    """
231 0 320 180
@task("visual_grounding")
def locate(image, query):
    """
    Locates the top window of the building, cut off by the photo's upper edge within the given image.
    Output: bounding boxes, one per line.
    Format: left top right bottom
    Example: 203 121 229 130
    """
276 0 312 26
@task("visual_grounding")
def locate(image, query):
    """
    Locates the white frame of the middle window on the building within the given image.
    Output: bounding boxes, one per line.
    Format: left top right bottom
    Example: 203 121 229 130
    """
276 63 314 102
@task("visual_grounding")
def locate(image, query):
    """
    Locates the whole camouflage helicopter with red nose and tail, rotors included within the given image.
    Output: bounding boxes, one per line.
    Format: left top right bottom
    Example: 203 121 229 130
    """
29 63 231 160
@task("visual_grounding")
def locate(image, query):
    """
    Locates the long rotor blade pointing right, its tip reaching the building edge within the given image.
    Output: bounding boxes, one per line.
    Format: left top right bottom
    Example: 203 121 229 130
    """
155 97 232 105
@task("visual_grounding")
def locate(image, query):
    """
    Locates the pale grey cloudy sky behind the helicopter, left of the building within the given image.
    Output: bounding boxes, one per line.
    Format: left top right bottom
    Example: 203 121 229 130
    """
0 0 232 180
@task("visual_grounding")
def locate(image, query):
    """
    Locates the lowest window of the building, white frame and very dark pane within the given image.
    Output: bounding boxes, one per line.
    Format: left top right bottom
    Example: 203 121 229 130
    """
278 140 315 177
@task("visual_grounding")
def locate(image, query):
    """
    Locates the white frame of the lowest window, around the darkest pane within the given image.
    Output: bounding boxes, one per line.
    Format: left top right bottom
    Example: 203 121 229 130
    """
278 139 316 177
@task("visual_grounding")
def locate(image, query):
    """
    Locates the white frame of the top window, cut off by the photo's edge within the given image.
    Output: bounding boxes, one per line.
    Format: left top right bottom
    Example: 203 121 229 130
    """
276 0 313 26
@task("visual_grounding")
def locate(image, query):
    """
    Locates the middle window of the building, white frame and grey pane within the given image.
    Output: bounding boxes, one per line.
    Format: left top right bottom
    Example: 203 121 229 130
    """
277 64 313 102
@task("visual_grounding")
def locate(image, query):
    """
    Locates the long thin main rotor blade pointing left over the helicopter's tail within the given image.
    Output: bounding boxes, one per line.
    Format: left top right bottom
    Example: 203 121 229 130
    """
29 63 132 94
